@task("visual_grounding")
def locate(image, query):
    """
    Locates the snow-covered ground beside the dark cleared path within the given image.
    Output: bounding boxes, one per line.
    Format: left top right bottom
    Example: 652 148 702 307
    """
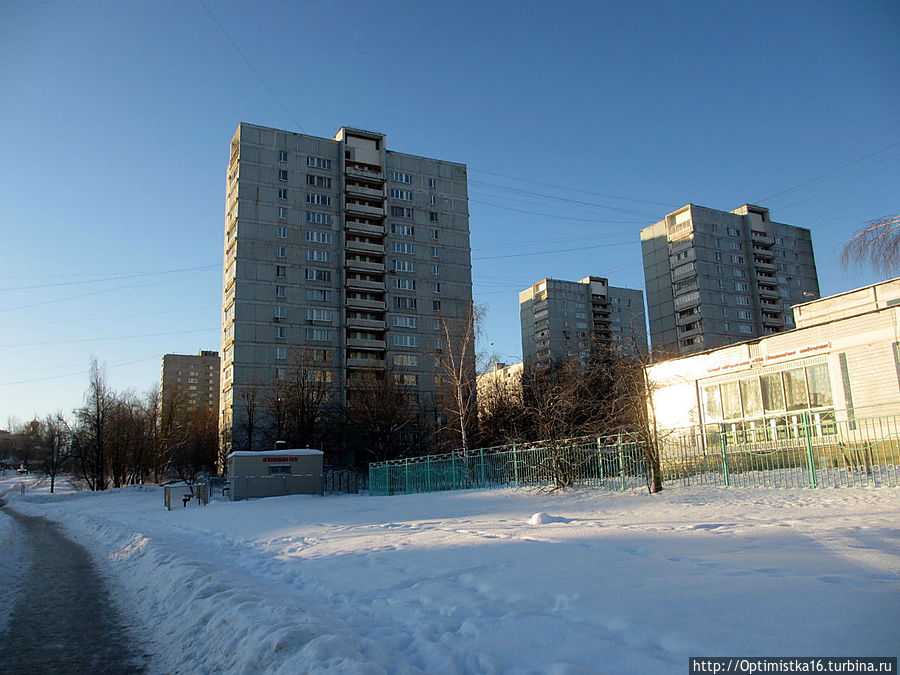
0 470 900 674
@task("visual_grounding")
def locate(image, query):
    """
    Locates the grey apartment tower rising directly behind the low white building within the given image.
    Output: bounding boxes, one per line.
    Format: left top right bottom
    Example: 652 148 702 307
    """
641 204 819 355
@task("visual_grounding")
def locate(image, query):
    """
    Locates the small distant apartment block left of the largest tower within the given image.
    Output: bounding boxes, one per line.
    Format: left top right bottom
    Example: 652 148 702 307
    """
159 350 220 419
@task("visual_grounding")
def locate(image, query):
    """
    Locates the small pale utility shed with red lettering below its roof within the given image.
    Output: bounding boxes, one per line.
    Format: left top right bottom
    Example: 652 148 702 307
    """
228 448 323 501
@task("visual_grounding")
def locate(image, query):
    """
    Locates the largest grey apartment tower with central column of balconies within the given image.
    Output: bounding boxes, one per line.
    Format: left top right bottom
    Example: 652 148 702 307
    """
221 123 472 447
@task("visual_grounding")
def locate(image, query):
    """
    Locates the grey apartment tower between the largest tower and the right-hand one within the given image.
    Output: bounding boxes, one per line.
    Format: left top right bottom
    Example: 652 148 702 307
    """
519 277 647 368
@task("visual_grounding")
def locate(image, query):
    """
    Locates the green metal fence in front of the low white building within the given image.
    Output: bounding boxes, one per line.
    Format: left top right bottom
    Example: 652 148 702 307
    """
369 406 900 495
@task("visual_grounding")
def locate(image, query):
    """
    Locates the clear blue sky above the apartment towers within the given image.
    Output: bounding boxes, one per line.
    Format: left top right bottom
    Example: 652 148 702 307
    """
0 0 900 428
